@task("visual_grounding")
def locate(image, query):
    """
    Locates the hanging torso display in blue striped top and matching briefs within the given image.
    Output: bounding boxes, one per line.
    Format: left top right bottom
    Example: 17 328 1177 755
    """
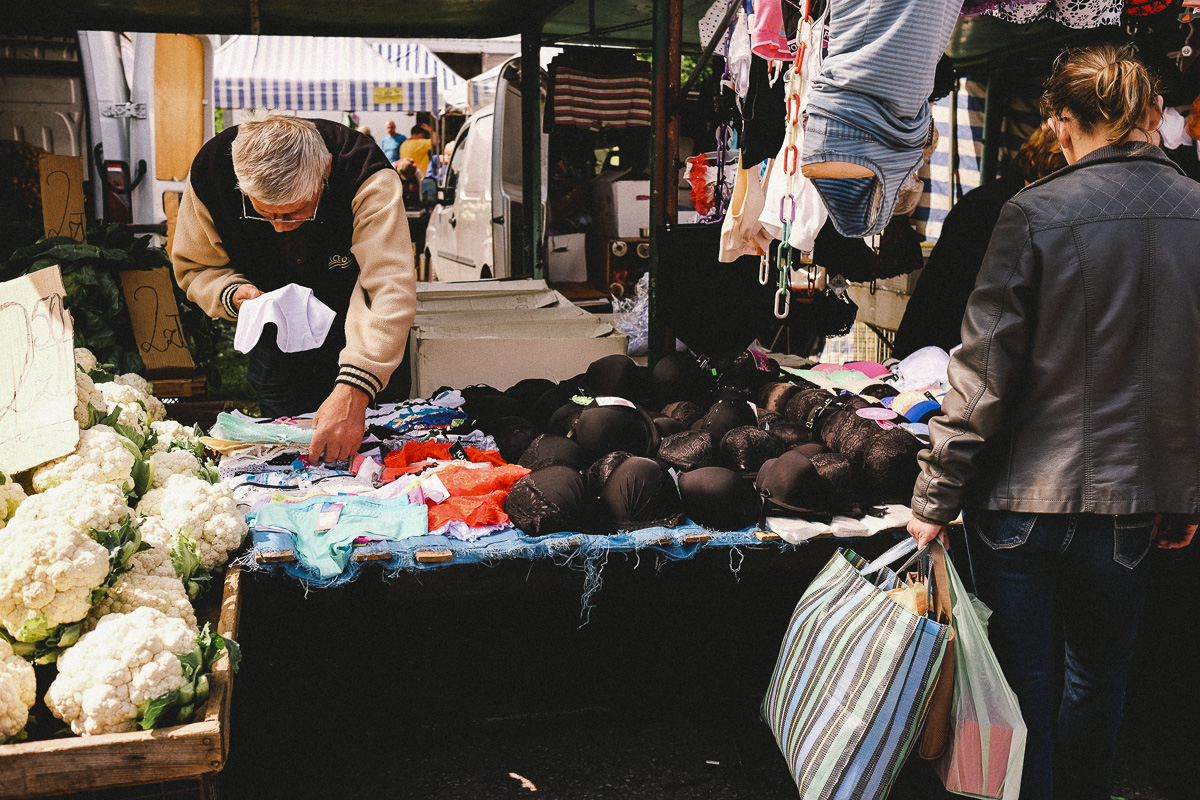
800 0 962 236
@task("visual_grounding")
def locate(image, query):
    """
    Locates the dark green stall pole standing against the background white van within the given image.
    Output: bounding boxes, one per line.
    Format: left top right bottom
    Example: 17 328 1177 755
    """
521 19 545 278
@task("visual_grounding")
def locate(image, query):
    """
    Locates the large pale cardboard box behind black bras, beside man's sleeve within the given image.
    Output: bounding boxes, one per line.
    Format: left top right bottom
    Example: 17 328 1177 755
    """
408 281 629 397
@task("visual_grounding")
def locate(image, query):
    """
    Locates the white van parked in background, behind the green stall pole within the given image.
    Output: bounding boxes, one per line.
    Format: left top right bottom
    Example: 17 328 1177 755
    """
424 58 550 281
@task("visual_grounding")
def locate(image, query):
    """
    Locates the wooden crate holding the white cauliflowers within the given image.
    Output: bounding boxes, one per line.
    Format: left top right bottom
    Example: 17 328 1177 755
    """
0 569 241 800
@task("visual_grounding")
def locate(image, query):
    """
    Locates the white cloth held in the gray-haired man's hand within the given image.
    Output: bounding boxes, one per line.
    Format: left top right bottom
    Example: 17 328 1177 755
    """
233 283 336 353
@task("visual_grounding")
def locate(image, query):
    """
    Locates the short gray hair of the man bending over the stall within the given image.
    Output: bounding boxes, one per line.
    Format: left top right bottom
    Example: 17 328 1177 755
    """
233 110 329 205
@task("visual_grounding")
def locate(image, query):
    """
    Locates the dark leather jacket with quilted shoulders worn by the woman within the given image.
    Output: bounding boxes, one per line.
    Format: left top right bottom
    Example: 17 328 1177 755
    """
912 144 1200 523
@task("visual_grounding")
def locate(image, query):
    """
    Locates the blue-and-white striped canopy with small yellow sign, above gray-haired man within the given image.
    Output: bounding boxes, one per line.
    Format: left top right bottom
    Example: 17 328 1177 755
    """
212 36 439 114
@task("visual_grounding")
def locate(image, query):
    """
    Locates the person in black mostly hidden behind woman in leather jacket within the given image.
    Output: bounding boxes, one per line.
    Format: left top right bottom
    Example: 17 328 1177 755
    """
892 122 1067 359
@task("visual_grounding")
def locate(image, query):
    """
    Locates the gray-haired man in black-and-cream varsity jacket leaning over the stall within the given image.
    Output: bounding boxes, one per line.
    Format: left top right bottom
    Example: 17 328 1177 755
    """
172 112 416 463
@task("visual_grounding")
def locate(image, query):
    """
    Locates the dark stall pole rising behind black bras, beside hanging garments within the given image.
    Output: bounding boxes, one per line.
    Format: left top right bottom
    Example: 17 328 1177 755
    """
648 0 683 363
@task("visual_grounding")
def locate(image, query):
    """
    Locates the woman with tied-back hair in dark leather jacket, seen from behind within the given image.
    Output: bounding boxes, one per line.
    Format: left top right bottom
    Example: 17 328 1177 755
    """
908 44 1200 800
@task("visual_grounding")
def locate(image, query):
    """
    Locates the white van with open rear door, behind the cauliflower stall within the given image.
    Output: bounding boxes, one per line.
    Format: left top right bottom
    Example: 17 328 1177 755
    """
0 31 216 234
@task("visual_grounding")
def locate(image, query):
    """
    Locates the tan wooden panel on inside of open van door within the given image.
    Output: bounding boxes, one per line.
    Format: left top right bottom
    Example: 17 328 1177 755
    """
154 34 204 181
